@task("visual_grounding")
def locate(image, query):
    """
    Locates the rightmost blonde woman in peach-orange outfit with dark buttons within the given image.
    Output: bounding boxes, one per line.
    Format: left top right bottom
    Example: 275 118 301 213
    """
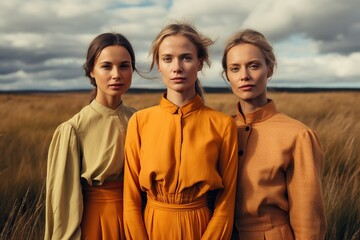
222 29 326 240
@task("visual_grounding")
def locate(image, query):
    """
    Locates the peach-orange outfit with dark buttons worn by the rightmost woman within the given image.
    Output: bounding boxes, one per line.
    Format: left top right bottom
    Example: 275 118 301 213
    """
234 100 326 240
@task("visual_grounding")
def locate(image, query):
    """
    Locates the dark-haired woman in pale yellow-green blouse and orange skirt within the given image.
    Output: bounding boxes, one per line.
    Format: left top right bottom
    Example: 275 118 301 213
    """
45 33 136 240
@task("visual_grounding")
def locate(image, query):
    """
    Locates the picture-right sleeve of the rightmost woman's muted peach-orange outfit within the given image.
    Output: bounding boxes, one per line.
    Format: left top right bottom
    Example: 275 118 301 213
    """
286 129 326 240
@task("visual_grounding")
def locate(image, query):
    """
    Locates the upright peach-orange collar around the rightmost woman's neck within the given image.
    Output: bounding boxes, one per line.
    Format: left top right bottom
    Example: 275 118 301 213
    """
235 99 278 124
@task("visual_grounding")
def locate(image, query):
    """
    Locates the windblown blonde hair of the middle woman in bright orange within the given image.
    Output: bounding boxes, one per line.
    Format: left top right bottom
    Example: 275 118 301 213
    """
149 23 214 99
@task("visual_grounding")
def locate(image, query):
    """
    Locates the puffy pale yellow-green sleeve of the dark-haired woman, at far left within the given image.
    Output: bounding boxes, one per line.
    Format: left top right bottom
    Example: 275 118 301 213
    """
45 122 83 239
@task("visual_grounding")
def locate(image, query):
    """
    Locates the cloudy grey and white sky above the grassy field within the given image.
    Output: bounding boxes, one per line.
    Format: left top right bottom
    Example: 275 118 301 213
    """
0 0 360 91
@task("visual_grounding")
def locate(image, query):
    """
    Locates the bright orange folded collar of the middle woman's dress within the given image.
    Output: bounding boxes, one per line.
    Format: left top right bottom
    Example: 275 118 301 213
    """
160 93 204 115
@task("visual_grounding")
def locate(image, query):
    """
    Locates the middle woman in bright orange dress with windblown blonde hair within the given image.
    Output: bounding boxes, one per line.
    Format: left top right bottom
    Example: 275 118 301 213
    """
124 23 238 240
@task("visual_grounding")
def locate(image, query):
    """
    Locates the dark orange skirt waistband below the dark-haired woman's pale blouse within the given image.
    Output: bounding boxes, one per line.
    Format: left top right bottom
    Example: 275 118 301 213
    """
83 181 123 202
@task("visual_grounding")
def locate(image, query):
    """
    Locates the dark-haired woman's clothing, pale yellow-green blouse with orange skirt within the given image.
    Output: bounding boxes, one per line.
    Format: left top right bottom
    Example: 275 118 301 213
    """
45 100 135 240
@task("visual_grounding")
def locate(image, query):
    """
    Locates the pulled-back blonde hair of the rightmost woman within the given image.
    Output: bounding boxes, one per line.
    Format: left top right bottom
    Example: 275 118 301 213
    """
222 29 277 77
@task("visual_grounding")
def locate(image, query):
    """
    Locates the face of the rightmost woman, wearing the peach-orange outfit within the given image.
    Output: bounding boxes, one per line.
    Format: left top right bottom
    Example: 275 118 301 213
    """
226 43 271 107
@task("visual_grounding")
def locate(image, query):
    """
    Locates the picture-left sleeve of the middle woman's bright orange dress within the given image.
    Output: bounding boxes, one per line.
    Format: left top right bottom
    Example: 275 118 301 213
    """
124 113 148 240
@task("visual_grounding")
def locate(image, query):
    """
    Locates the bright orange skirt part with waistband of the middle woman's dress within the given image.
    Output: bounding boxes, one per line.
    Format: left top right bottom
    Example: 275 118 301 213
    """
144 197 212 240
